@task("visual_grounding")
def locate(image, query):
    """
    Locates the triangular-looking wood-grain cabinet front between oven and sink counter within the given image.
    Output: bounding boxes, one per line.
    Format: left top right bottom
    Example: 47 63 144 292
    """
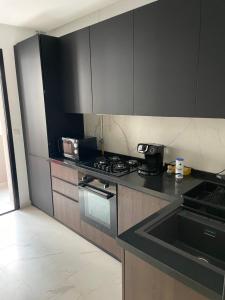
118 185 169 234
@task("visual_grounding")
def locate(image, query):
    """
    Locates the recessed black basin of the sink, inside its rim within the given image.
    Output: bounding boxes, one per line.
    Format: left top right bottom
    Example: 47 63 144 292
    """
145 209 225 270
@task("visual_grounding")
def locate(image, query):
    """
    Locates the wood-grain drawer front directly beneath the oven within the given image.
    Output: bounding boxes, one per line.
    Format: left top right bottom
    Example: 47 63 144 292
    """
81 221 122 260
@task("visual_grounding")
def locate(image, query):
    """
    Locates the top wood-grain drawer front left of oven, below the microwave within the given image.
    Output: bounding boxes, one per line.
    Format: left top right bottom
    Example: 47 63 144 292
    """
51 162 78 184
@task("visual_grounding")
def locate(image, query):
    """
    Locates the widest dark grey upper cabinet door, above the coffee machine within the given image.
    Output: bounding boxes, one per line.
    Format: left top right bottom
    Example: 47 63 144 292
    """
134 0 200 116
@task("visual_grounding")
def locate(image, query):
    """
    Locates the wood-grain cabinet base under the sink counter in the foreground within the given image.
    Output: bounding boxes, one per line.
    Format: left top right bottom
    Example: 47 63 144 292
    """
123 251 209 300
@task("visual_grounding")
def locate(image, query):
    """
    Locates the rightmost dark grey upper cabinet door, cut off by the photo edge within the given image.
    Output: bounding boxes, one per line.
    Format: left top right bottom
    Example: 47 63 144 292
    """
197 0 225 118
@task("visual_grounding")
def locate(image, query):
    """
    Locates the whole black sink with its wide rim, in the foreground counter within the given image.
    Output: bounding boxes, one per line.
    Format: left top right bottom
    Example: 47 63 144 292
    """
135 204 225 295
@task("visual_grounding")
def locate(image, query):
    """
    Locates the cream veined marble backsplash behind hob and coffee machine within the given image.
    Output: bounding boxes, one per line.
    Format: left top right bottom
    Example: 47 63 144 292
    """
84 114 225 173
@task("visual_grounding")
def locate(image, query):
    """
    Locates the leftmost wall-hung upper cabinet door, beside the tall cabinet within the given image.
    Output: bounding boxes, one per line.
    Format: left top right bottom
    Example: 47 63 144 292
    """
60 27 92 113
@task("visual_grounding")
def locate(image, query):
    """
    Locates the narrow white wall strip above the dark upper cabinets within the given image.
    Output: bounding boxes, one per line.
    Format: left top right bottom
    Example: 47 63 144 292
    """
49 0 156 36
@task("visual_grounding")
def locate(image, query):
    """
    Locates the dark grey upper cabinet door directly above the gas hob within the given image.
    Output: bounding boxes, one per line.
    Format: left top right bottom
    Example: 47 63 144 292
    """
90 12 133 114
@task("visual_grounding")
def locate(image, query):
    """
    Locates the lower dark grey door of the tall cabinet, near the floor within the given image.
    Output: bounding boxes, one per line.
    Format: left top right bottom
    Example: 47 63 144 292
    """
28 155 53 216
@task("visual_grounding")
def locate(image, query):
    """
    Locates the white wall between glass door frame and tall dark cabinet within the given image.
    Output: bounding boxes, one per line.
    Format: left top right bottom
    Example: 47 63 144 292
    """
0 24 35 207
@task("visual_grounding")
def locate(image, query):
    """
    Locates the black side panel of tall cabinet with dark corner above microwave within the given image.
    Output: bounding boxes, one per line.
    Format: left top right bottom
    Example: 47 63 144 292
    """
40 35 84 149
